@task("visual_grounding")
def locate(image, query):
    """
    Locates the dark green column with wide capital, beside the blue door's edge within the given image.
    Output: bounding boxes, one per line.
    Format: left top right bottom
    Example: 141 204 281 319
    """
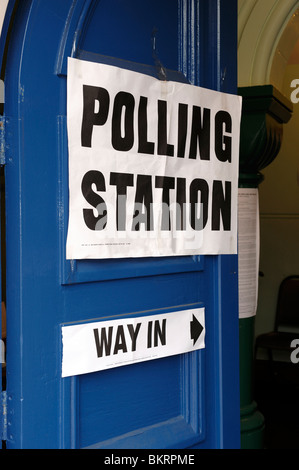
238 85 292 449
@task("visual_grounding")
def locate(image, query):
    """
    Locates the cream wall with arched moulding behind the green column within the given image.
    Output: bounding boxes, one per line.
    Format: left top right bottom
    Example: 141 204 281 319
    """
238 0 299 335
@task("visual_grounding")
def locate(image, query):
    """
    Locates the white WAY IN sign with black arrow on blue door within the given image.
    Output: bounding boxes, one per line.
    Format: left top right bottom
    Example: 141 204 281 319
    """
62 308 205 377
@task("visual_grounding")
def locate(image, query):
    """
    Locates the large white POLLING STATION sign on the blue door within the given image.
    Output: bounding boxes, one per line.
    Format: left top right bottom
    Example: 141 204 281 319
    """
66 58 241 259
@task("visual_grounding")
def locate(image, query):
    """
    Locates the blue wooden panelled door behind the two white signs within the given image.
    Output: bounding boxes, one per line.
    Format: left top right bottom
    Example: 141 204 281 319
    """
3 0 239 449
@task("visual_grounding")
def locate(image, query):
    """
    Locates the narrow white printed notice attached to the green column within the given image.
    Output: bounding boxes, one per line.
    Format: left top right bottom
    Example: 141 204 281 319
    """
238 188 260 318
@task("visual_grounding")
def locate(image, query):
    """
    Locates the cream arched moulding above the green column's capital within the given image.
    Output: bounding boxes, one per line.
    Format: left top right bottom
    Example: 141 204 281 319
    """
238 0 299 91
